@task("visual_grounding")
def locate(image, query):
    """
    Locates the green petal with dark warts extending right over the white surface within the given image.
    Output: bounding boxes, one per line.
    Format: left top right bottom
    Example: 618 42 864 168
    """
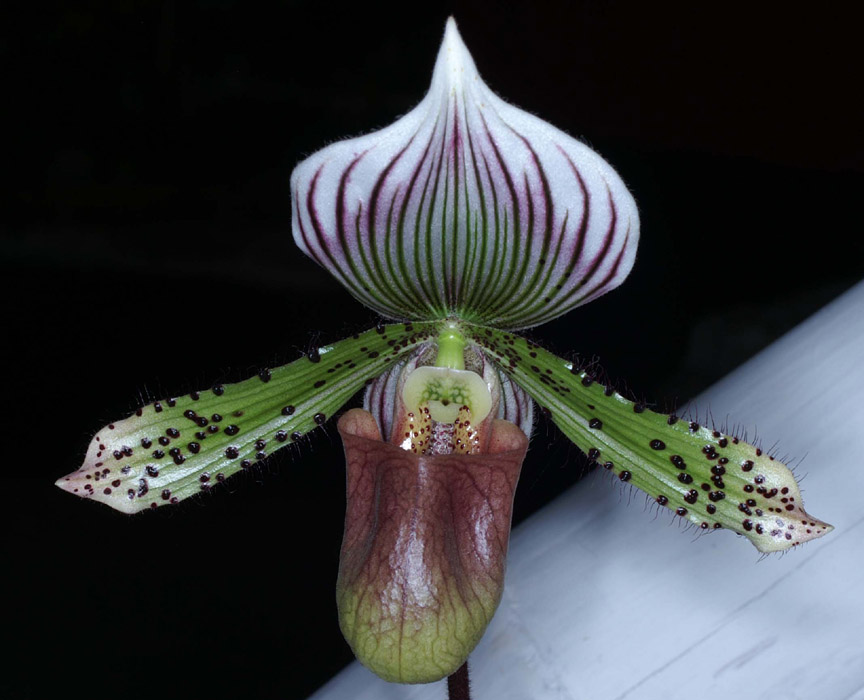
464 325 833 552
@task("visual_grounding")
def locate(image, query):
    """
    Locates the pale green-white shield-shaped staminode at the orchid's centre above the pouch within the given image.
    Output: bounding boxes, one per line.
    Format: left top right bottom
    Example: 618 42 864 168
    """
402 367 492 426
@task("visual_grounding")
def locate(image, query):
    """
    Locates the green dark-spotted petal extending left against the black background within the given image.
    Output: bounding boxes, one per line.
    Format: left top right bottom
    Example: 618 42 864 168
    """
57 323 436 513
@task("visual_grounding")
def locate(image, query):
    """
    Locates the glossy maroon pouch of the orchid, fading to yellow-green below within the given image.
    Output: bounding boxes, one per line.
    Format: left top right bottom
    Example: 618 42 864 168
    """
336 409 528 683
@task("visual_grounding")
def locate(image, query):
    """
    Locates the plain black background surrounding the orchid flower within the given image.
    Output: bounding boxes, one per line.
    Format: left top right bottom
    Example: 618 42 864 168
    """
0 0 864 698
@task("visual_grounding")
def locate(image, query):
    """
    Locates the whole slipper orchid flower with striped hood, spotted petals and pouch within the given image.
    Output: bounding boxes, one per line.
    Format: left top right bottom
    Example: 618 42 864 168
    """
57 20 831 683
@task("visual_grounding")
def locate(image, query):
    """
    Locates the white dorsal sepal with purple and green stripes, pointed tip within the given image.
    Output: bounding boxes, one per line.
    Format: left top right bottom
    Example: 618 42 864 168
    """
291 19 639 328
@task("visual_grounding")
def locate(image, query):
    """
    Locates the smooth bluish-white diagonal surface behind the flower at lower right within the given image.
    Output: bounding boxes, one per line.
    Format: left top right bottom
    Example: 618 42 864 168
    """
312 282 864 700
